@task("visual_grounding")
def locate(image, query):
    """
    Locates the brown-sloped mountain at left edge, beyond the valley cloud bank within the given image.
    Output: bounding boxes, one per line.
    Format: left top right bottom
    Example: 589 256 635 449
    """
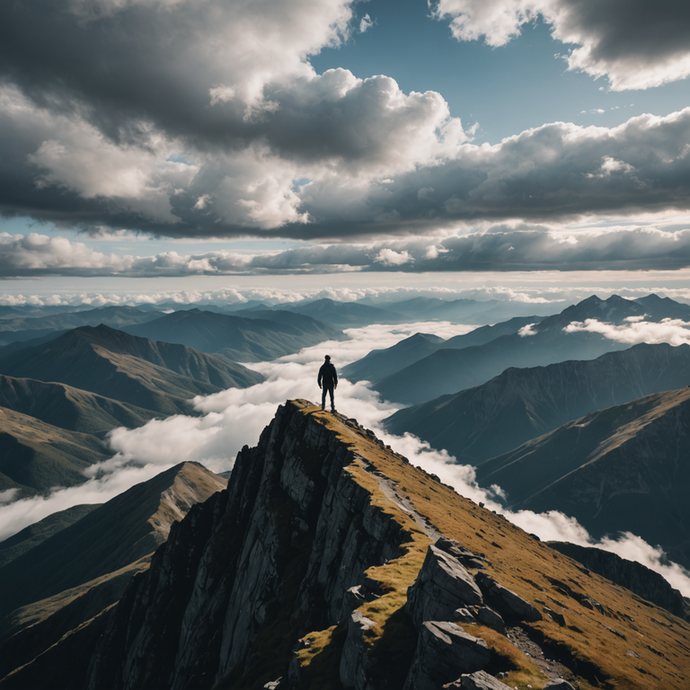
0 325 264 496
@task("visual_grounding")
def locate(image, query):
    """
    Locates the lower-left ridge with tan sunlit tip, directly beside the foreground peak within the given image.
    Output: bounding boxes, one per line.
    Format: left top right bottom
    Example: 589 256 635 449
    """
0 463 227 676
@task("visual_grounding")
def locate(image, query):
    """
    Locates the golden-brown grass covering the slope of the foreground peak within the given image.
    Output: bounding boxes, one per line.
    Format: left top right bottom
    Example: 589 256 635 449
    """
290 401 690 690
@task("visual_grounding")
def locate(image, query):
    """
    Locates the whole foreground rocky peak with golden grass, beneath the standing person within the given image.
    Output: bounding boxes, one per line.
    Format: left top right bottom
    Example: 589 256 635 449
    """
5 400 690 690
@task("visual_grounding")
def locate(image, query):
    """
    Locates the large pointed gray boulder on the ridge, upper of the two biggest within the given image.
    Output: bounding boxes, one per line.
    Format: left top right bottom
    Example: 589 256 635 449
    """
406 546 483 627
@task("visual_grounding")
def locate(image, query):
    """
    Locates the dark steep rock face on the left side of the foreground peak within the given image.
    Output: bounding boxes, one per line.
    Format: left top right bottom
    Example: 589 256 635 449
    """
88 403 409 690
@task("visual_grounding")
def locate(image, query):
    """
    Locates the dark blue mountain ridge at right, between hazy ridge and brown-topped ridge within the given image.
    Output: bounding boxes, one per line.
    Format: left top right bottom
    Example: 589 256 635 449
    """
384 344 690 465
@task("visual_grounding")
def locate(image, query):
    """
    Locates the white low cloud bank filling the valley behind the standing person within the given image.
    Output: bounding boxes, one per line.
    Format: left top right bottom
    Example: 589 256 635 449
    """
0 323 690 596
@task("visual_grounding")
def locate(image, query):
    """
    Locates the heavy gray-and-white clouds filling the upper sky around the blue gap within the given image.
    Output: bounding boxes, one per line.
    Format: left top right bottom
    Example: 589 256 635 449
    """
0 0 690 242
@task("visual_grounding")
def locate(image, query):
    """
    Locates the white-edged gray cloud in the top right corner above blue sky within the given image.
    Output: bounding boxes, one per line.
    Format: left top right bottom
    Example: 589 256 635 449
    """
433 0 690 91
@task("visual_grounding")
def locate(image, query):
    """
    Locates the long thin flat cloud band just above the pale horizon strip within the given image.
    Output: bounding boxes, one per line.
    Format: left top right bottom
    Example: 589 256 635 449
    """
6 220 690 278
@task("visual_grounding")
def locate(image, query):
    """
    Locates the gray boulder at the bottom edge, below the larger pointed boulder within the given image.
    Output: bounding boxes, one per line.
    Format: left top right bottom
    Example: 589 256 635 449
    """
403 621 491 690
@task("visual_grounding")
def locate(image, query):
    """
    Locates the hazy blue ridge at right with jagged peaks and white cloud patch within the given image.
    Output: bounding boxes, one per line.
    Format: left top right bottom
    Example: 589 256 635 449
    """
373 295 690 404
